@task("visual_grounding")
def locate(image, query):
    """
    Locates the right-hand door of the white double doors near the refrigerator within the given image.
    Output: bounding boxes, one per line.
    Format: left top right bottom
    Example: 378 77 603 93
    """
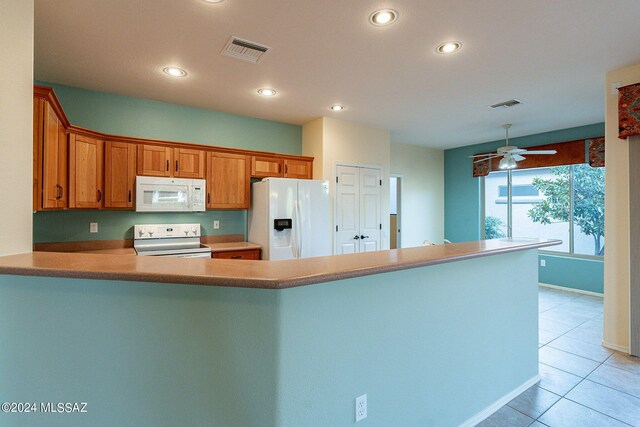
360 168 382 252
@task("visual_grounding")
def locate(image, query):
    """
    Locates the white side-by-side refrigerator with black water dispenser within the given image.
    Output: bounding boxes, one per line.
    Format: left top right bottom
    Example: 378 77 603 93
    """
248 178 331 260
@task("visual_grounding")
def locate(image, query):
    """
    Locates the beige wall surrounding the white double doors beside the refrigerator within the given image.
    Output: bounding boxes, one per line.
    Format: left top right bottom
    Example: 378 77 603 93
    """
302 117 391 249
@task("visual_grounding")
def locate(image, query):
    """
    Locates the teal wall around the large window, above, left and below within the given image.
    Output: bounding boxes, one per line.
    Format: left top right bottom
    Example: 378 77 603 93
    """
444 123 604 293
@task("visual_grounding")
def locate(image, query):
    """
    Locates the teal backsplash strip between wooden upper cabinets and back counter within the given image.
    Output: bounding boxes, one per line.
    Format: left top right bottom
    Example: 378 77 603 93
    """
33 210 247 243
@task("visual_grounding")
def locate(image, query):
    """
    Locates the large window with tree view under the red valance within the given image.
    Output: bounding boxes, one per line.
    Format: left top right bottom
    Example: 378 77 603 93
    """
484 164 604 256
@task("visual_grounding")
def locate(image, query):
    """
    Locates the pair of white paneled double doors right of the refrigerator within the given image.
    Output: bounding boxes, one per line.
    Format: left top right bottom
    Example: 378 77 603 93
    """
335 165 382 254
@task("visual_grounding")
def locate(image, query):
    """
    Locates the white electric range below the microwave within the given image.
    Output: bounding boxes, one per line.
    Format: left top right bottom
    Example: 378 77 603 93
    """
133 224 211 258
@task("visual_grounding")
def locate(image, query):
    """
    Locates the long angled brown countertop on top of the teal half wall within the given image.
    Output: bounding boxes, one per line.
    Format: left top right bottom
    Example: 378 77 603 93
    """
0 239 562 289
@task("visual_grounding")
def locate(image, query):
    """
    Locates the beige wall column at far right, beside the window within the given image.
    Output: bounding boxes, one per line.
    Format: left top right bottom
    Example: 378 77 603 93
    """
604 64 640 351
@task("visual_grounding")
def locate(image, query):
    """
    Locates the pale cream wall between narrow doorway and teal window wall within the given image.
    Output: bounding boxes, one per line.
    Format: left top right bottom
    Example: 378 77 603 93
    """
391 143 444 248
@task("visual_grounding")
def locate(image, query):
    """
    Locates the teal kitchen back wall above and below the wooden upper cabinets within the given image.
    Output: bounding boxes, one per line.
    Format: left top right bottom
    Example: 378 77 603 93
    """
33 82 302 243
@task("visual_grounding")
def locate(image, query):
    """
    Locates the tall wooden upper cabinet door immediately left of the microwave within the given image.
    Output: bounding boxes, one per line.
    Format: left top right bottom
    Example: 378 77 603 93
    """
104 141 136 208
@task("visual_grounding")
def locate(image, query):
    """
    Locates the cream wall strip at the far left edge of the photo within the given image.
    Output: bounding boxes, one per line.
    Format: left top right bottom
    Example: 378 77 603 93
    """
0 0 33 255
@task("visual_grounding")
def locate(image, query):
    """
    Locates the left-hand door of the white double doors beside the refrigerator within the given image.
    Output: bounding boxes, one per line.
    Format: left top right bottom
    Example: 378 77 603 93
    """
335 165 360 255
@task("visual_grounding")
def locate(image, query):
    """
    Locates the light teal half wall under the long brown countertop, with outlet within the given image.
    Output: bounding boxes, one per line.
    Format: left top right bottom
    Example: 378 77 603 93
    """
0 250 538 427
